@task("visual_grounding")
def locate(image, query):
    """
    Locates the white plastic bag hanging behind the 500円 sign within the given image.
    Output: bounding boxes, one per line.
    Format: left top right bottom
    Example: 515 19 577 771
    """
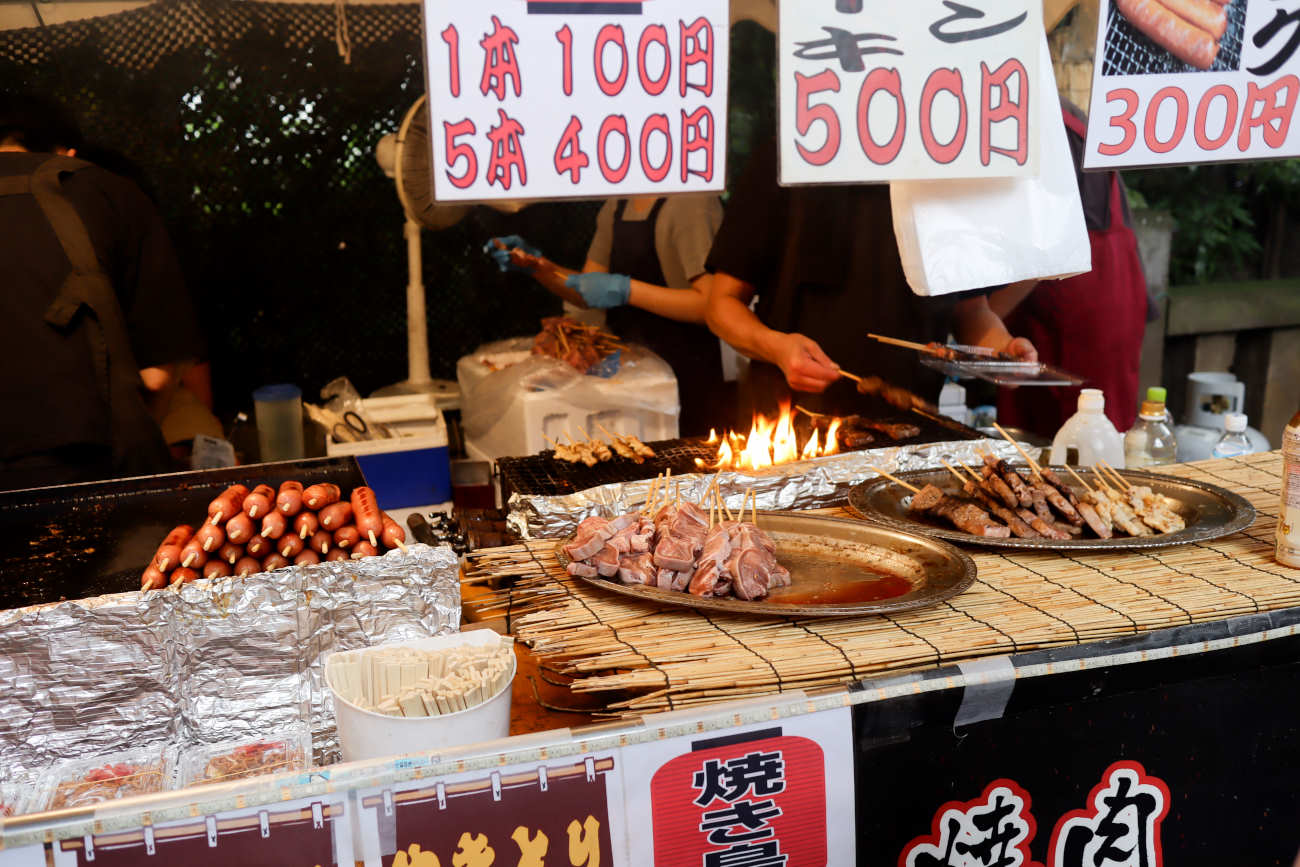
889 35 1092 295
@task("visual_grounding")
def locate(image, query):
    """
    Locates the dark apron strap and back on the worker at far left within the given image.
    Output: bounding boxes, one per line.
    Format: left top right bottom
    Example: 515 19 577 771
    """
0 156 172 476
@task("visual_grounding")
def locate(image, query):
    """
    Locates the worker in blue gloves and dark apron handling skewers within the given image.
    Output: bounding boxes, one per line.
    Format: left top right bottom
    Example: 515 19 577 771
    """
485 195 725 437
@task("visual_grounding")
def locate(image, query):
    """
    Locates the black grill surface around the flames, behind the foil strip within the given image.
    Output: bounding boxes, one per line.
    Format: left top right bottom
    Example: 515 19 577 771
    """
497 413 983 499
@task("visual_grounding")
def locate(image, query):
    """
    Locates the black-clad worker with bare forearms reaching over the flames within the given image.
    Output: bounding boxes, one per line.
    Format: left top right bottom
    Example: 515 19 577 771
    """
707 138 1037 417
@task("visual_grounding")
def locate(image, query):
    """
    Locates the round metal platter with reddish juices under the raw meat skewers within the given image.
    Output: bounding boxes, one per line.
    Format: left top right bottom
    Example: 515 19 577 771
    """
555 512 975 617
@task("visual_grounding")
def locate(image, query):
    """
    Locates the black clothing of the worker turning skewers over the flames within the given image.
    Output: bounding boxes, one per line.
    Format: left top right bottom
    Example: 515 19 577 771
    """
709 140 959 416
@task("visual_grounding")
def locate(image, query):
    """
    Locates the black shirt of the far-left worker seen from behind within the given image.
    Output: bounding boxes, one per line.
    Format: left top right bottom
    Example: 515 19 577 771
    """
0 152 204 459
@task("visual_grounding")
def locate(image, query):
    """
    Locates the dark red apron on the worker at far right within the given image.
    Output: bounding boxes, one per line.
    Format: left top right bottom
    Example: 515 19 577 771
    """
997 112 1147 437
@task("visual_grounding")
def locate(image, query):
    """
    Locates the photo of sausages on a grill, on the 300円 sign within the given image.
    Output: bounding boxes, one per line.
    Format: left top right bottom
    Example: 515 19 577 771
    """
1101 0 1247 75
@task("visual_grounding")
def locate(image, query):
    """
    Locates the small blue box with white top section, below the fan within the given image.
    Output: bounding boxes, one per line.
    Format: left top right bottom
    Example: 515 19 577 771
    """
325 395 451 508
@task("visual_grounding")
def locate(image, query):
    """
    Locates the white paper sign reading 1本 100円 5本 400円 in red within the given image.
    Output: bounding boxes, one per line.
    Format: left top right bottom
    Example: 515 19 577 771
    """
424 0 729 201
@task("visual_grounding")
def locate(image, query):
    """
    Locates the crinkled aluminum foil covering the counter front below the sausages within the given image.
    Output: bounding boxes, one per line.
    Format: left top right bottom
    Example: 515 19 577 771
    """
0 545 460 780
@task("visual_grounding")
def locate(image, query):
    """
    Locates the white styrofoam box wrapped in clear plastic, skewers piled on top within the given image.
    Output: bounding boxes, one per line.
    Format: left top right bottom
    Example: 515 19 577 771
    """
458 352 680 460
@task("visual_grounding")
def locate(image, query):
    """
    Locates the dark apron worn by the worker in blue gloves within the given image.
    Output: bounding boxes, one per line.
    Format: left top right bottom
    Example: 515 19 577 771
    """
606 199 727 437
